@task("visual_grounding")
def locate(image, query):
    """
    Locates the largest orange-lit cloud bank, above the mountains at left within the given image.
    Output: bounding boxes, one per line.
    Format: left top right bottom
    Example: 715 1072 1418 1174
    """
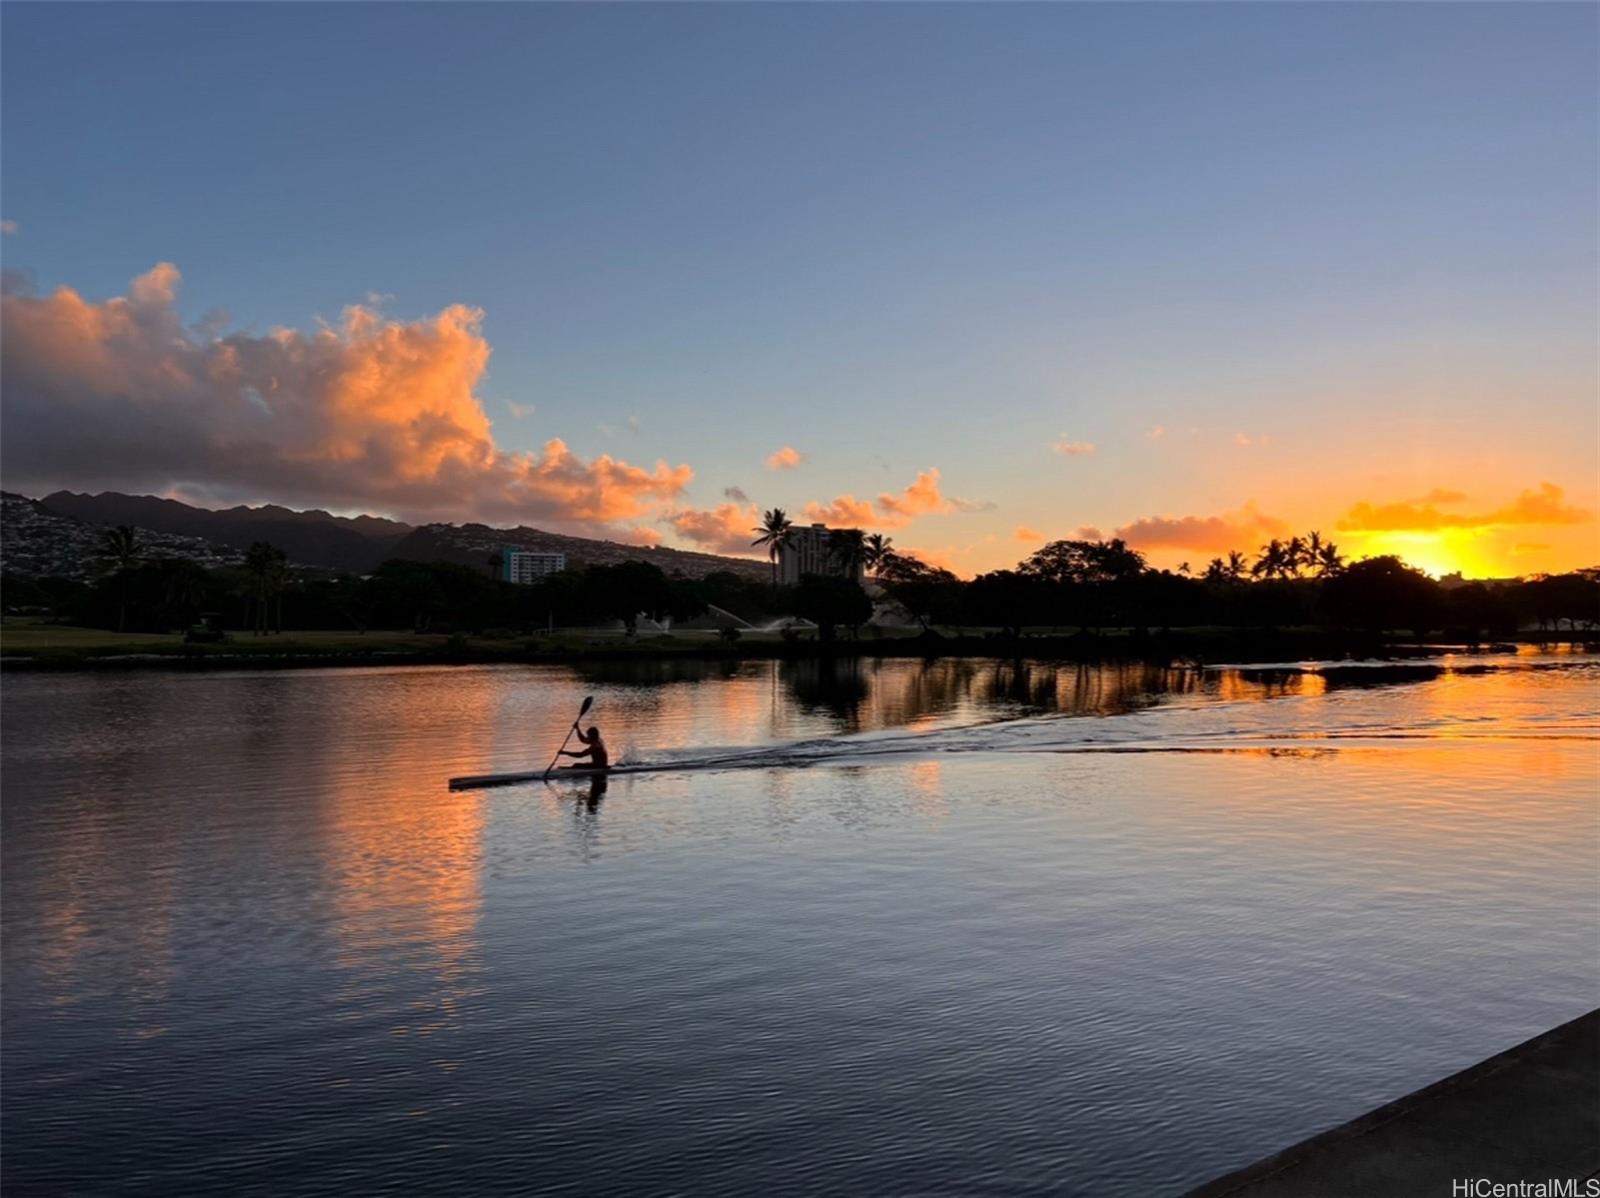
0 270 694 533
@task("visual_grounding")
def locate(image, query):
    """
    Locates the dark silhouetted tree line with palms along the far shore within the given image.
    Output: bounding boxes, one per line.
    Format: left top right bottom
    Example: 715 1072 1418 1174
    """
5 509 1600 641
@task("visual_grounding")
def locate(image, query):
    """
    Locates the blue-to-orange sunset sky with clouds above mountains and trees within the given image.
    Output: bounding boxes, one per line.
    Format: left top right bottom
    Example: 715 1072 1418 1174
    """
0 3 1600 576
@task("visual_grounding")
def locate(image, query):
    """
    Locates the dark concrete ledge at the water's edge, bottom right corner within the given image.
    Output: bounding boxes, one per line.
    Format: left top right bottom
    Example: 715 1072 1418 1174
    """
1189 1009 1600 1198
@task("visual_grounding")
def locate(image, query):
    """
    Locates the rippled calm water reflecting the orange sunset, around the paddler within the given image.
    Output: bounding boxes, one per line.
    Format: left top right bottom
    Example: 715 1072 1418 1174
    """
0 656 1600 1195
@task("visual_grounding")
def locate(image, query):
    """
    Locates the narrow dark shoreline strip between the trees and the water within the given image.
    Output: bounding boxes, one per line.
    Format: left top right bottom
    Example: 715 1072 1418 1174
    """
0 630 1586 672
